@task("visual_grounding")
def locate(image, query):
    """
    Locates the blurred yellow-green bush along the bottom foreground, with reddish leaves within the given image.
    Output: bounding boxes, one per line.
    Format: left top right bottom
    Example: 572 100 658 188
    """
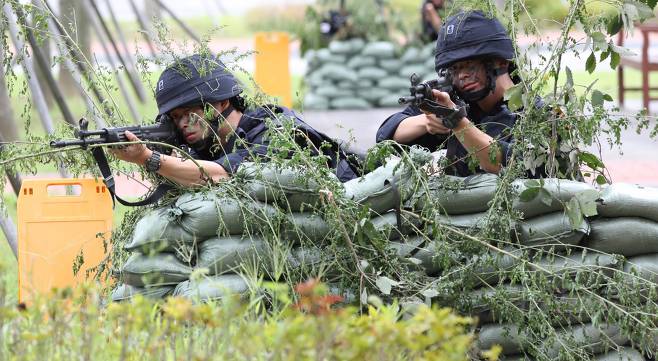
0 283 482 360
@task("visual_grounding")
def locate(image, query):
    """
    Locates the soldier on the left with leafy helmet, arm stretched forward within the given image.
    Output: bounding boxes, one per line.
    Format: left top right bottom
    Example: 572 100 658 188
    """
113 55 357 185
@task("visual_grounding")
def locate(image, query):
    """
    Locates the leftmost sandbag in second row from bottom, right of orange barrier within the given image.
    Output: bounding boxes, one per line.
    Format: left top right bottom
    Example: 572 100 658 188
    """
119 253 192 287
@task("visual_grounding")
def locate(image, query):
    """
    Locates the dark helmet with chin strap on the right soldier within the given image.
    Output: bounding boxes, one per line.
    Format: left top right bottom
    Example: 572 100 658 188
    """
434 11 514 102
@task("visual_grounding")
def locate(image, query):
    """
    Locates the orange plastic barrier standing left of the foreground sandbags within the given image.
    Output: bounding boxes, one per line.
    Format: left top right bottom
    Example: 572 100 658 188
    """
18 179 112 302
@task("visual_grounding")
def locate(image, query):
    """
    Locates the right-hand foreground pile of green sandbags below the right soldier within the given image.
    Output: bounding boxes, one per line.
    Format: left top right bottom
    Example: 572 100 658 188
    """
396 174 658 360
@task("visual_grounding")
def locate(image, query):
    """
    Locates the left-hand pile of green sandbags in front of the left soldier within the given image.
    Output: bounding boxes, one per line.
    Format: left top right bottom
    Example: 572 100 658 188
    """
112 159 426 301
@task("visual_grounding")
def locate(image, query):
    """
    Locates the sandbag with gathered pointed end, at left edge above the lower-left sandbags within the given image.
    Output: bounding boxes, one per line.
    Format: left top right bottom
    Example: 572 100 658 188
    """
124 206 196 253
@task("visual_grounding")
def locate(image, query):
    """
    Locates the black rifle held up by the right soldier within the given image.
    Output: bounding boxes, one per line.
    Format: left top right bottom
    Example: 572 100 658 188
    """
398 70 468 129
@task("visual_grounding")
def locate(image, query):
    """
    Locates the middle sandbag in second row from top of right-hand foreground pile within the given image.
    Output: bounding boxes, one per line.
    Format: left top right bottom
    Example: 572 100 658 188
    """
517 212 590 249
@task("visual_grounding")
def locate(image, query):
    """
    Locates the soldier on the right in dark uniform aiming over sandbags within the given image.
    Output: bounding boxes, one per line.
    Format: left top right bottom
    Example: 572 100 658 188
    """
377 11 541 176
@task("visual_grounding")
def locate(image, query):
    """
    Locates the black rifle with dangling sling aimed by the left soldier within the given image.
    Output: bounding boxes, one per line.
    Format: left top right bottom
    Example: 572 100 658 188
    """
50 115 181 207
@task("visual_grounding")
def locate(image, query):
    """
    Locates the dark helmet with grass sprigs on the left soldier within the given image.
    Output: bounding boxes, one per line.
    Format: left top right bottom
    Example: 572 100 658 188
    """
155 54 242 115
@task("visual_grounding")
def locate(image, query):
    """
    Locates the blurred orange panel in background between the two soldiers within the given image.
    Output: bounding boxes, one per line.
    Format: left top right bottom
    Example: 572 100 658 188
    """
254 33 292 108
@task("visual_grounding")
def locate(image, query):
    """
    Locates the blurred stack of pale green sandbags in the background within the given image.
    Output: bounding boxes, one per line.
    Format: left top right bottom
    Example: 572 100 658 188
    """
304 39 436 110
